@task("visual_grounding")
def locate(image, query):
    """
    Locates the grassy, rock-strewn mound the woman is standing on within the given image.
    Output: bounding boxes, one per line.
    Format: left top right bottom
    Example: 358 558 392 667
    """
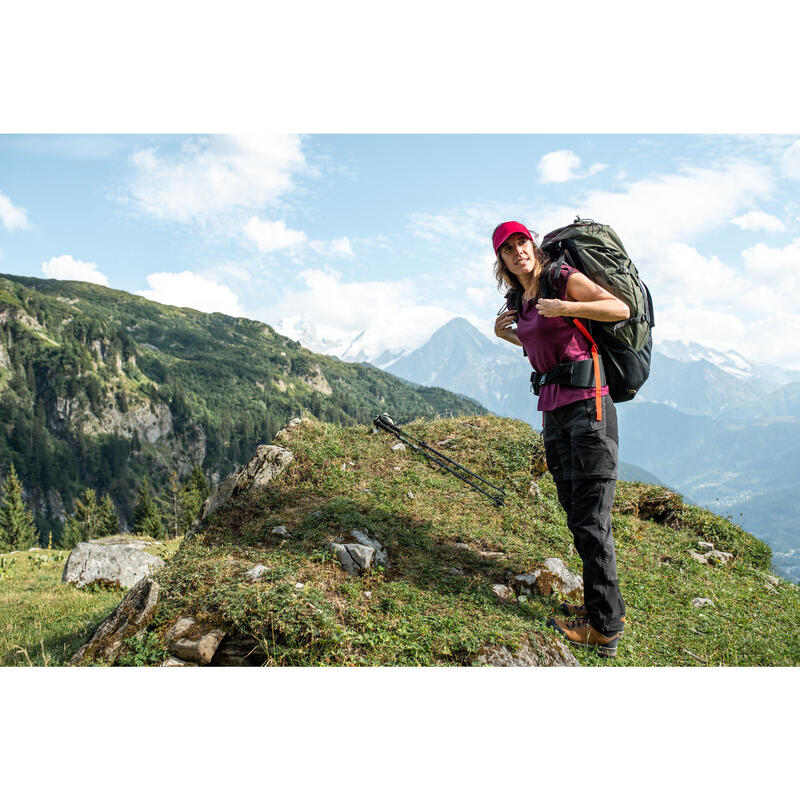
39 416 800 666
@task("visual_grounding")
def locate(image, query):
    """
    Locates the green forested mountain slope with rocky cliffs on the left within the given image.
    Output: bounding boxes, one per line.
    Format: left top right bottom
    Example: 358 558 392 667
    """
0 275 485 541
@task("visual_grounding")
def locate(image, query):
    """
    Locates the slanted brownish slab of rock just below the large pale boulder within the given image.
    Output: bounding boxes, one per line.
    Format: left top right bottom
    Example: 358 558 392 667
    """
69 578 158 666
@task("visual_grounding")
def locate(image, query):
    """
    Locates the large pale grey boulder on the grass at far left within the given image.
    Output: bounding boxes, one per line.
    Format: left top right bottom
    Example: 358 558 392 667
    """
61 536 164 589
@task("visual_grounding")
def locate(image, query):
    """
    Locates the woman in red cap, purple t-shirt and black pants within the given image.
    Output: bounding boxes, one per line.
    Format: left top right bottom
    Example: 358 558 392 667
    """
492 222 630 658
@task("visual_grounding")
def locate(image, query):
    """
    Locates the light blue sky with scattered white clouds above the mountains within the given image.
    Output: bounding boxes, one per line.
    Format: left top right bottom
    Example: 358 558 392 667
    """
0 134 800 369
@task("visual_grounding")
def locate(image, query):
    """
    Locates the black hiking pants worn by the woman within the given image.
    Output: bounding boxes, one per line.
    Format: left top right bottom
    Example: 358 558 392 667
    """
542 395 625 636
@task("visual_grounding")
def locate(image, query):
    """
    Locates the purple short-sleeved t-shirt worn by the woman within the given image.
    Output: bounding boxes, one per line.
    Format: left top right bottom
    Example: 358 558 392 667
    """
517 264 608 411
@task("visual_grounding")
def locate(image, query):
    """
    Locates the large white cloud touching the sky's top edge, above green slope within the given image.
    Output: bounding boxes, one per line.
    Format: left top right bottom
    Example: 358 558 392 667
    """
129 135 306 223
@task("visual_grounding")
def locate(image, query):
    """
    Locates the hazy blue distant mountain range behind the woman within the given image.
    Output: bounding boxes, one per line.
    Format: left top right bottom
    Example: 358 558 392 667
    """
368 319 800 580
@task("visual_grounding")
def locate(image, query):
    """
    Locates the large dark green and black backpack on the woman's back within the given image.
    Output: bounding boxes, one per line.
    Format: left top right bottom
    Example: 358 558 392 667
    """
541 217 655 403
